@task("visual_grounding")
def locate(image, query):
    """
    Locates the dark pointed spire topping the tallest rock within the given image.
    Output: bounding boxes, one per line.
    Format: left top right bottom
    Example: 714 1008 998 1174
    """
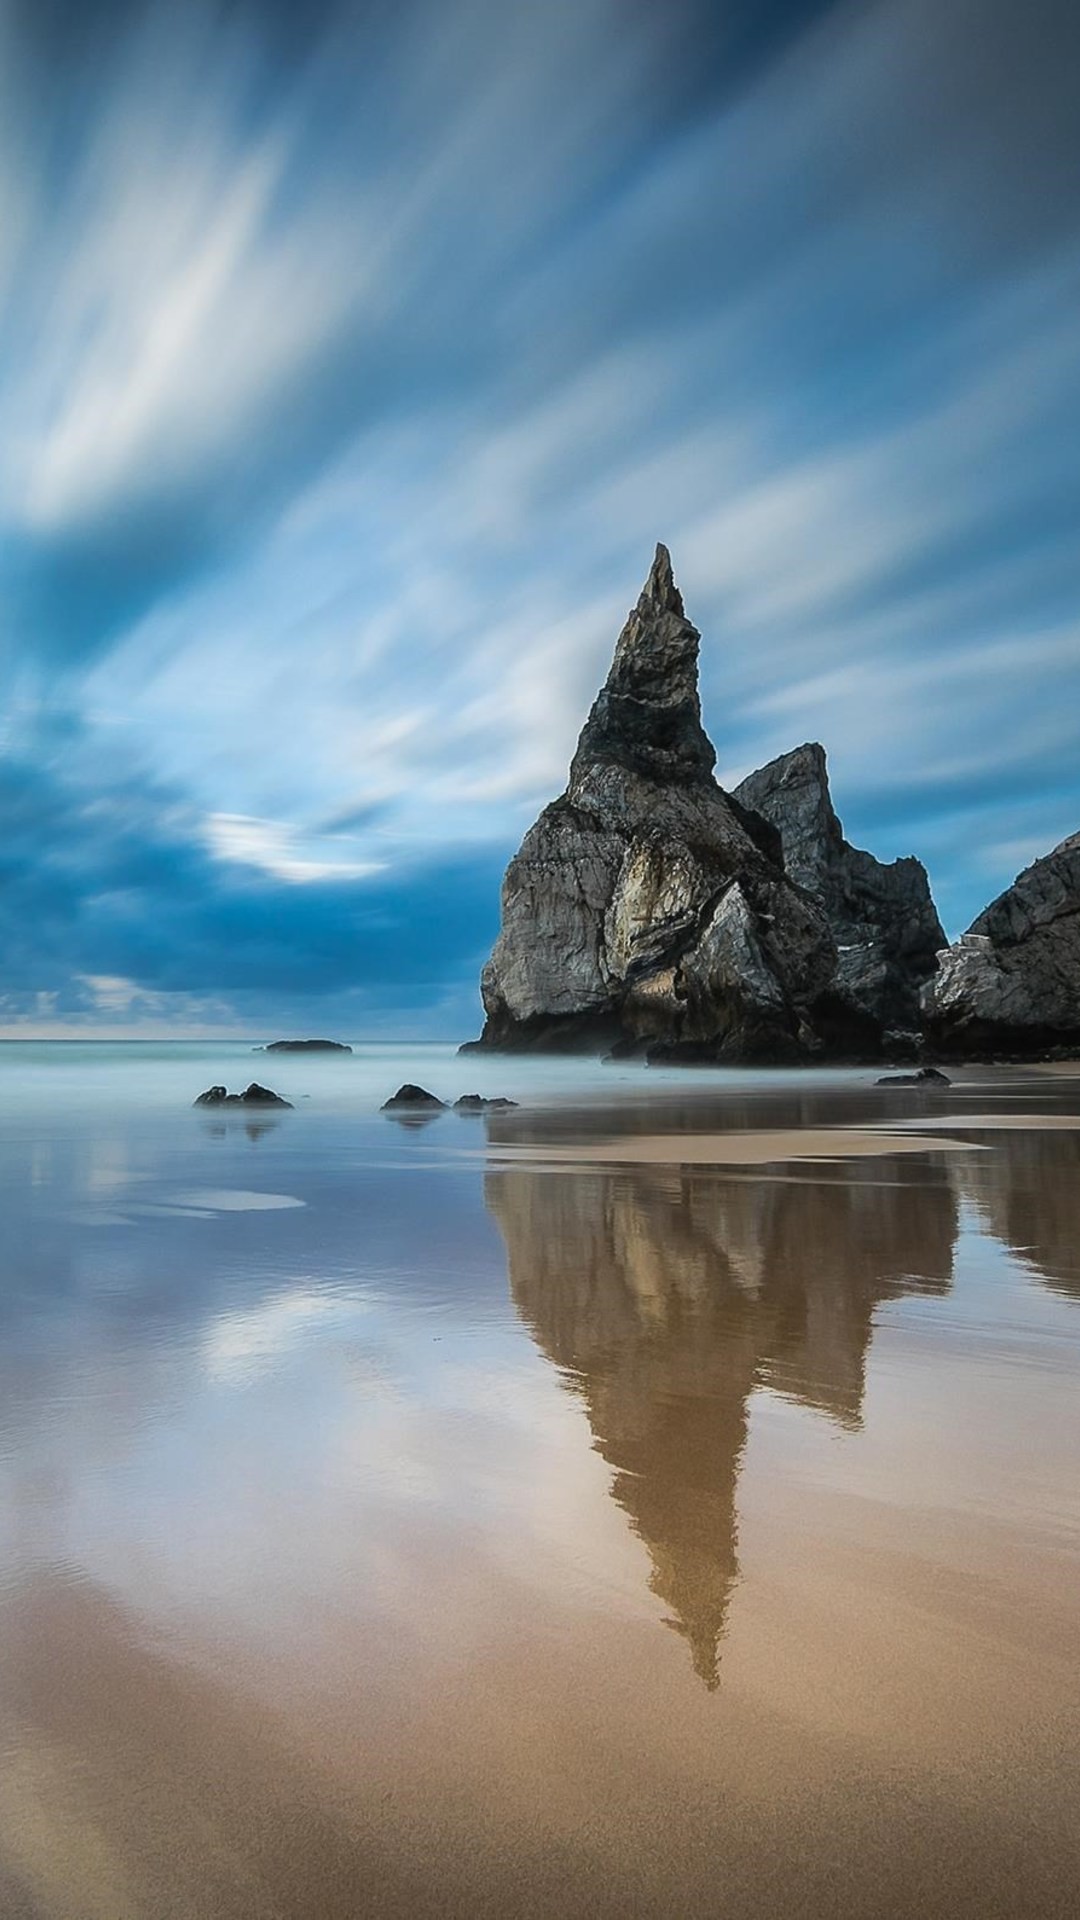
571 545 717 793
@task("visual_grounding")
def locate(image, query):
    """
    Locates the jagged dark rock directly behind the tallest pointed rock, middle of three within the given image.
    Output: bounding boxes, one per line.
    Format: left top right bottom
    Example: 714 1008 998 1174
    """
736 743 945 1039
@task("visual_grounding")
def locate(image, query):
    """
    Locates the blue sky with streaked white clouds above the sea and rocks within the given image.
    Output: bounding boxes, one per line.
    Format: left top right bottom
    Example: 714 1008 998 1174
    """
0 0 1080 1039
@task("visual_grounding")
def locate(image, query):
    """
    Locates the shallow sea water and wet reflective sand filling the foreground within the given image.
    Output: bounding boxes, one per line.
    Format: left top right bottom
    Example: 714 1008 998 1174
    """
0 1044 1080 1920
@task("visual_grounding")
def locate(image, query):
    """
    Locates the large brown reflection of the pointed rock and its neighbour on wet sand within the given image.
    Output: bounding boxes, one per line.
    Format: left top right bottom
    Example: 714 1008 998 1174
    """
486 1133 955 1686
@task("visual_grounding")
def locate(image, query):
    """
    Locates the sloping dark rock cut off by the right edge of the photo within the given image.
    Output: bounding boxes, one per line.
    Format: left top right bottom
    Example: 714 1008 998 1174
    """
922 833 1080 1060
